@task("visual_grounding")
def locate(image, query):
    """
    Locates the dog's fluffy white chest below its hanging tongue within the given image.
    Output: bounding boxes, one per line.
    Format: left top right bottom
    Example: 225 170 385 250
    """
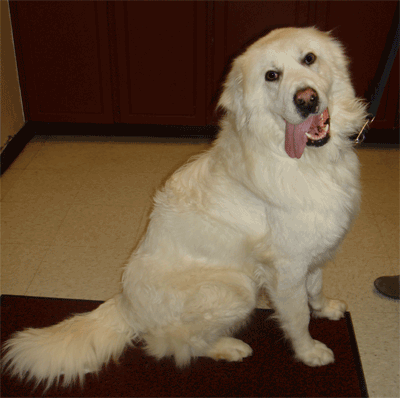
260 153 360 256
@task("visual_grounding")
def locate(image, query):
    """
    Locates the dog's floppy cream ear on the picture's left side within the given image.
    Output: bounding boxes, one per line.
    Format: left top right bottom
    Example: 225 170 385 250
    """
218 57 243 115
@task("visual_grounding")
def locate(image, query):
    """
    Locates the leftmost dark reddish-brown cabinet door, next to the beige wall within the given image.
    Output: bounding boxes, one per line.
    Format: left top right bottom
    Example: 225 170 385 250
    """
10 1 113 123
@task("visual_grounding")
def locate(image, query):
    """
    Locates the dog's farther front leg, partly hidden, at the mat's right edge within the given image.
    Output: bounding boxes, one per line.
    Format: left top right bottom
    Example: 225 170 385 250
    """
307 268 347 321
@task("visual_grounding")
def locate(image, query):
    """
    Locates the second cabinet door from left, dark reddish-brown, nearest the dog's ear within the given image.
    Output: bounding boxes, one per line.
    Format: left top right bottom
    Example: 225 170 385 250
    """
116 2 206 125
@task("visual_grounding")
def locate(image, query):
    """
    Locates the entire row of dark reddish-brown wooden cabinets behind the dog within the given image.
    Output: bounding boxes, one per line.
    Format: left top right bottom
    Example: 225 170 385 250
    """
10 0 399 135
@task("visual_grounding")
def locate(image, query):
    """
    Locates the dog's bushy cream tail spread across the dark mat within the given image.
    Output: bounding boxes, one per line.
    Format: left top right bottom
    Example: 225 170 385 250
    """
2 295 137 390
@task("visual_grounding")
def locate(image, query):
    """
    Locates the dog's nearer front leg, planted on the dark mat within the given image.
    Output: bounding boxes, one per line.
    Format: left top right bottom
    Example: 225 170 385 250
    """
269 269 334 366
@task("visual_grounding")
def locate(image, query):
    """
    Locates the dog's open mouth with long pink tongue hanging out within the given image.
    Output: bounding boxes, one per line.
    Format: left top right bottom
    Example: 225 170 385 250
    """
285 108 330 159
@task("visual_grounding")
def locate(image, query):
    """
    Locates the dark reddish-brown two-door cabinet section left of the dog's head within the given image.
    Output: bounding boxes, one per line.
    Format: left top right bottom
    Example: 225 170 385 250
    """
10 1 209 125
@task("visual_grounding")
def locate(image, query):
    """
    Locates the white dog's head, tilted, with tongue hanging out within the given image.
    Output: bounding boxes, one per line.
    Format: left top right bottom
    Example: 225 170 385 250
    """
219 28 365 158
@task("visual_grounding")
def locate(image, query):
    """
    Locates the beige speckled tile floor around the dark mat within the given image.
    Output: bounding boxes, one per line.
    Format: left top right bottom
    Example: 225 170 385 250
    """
1 136 399 397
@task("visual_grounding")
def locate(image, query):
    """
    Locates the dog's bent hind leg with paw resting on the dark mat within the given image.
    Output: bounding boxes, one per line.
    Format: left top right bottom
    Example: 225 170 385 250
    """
144 270 256 367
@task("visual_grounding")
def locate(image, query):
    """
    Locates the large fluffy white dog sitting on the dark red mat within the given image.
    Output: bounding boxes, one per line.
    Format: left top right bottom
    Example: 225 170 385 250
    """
3 28 366 387
